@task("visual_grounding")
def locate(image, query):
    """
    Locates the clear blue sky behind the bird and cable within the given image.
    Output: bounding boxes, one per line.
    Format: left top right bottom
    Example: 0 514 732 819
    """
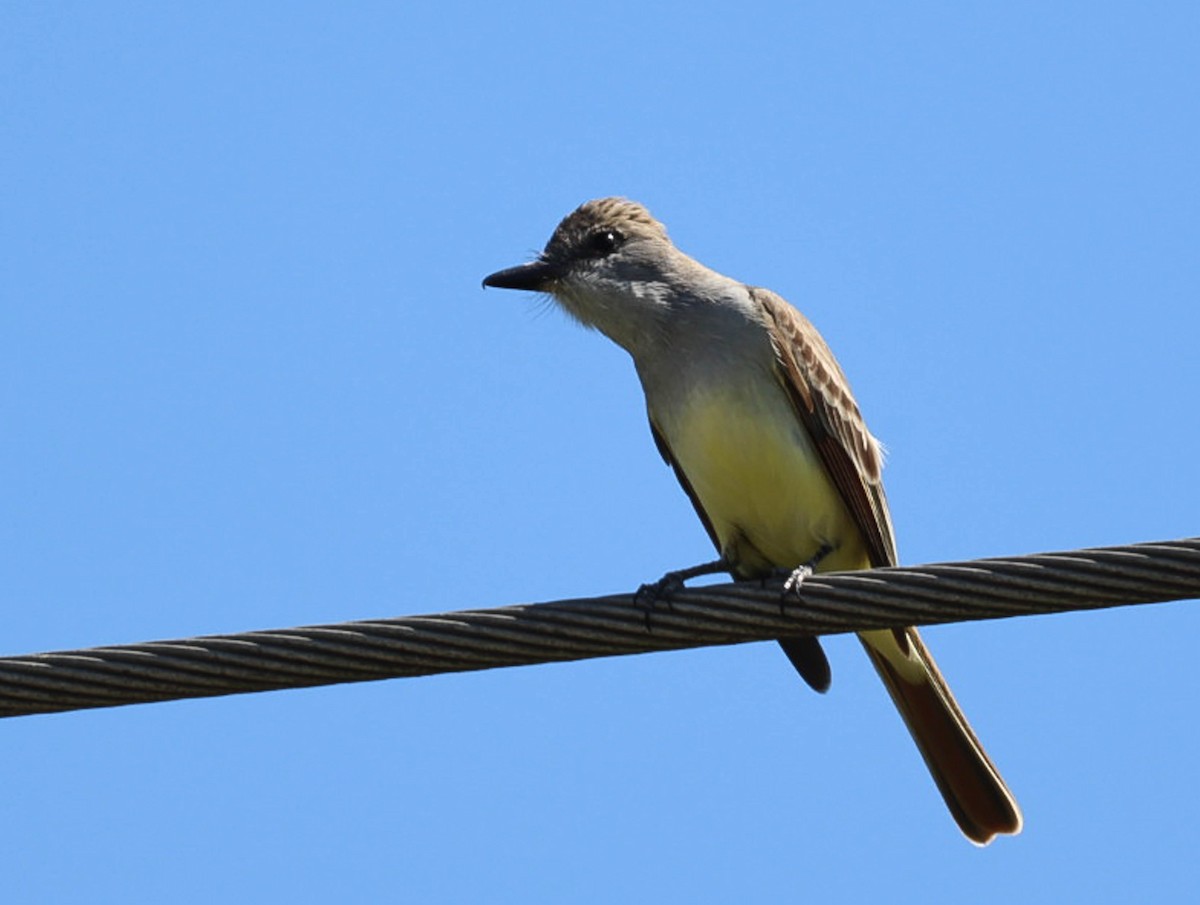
0 2 1200 903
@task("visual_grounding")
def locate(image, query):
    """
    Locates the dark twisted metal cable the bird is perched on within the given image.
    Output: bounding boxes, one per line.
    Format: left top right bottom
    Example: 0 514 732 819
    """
0 538 1200 717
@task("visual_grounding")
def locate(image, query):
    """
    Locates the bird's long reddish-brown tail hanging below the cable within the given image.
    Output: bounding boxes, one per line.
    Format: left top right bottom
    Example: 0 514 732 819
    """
859 628 1021 845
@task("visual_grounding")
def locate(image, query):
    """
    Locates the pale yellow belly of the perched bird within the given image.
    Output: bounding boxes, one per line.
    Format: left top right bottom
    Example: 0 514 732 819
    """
666 386 869 576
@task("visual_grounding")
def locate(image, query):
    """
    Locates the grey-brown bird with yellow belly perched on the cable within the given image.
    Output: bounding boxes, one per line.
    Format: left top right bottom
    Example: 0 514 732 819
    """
484 197 1022 845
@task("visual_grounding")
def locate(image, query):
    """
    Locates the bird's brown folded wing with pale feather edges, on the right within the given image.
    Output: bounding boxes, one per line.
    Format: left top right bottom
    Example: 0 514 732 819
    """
750 287 896 567
